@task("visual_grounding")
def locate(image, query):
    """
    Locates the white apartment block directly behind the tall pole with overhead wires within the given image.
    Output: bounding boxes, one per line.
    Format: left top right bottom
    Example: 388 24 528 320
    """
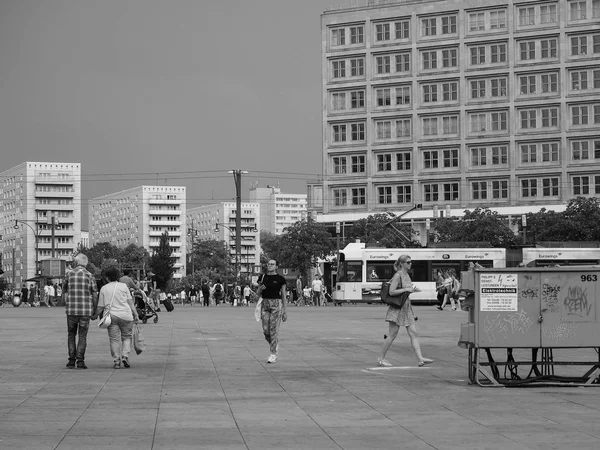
186 202 260 276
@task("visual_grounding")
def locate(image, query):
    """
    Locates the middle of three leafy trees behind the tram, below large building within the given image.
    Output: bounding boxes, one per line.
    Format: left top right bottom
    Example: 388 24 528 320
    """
430 208 517 247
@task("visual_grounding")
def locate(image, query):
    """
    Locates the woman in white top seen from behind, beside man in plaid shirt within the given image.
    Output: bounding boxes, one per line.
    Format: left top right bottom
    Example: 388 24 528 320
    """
96 267 139 369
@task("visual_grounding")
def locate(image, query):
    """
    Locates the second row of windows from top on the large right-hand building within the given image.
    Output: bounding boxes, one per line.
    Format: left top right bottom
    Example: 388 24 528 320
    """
329 33 600 81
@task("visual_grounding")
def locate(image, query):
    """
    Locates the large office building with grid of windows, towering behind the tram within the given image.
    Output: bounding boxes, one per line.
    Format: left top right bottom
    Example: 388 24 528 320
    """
316 0 600 237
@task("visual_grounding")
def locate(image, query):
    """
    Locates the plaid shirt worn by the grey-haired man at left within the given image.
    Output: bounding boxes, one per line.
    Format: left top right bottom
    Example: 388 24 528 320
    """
64 266 98 316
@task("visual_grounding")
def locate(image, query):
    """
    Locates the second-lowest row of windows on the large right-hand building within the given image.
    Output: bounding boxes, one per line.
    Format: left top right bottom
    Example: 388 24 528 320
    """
330 138 600 175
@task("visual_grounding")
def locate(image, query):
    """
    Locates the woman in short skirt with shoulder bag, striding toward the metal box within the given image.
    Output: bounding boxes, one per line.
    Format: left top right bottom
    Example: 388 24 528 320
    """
377 255 433 367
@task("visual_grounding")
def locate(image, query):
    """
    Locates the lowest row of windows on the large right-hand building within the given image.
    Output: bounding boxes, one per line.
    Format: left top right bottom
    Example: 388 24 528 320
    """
331 175 600 208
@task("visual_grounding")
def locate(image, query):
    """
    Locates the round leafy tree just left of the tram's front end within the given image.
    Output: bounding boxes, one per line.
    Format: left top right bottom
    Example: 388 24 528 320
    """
275 218 336 275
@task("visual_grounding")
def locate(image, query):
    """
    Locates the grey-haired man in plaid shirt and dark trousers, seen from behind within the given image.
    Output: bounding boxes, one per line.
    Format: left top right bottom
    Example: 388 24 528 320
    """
63 253 98 369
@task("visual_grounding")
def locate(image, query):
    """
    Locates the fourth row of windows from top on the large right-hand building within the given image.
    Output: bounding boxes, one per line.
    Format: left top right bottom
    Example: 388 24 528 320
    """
329 103 600 145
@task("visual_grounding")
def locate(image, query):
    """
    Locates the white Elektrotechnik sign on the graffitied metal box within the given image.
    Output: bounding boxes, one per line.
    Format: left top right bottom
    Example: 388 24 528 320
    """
479 273 519 311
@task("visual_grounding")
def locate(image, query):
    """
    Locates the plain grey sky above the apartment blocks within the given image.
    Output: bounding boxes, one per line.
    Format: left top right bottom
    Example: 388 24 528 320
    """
0 0 346 209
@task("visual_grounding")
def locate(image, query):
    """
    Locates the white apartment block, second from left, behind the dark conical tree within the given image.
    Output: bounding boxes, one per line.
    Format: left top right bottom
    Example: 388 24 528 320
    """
89 186 186 278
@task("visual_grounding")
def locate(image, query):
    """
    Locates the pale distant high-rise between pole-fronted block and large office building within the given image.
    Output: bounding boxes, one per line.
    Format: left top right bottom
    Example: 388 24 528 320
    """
249 184 306 235
